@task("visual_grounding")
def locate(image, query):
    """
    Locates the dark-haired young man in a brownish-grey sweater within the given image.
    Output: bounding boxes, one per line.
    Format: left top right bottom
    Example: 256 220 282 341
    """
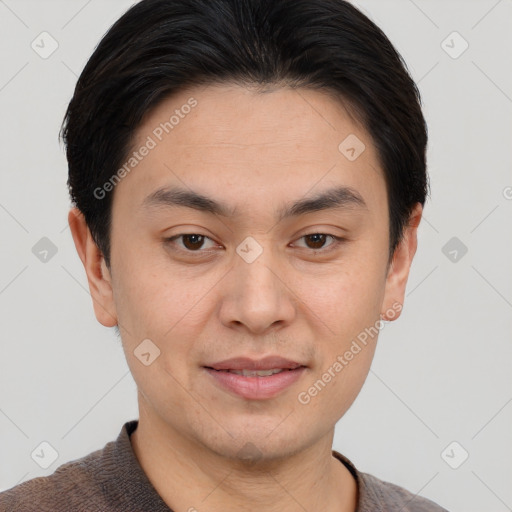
0 0 444 512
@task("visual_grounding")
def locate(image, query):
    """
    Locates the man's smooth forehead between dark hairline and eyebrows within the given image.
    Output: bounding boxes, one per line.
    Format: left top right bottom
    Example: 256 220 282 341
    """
116 85 385 220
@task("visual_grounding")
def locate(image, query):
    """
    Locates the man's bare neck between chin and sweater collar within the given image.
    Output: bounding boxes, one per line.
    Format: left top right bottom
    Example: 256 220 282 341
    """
131 400 357 512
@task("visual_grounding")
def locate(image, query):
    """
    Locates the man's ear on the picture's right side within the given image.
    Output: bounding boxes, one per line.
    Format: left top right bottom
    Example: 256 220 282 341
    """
381 203 423 321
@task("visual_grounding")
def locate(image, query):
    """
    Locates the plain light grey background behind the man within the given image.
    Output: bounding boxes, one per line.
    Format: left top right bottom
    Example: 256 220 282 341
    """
0 0 512 512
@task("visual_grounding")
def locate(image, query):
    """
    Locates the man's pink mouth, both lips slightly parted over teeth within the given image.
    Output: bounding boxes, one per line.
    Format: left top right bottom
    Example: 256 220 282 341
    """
203 356 307 400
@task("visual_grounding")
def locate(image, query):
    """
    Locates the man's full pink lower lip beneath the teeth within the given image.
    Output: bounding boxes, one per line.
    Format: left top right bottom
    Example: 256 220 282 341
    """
205 366 306 400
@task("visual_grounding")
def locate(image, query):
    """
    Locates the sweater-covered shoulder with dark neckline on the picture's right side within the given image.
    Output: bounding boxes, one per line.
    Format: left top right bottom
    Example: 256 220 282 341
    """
333 450 448 512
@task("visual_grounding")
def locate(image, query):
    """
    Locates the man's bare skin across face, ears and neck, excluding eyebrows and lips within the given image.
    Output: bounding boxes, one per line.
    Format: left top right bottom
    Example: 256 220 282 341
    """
69 84 422 512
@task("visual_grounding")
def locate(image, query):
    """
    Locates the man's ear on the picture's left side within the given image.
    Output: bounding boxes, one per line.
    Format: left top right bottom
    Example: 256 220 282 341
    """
68 208 117 327
